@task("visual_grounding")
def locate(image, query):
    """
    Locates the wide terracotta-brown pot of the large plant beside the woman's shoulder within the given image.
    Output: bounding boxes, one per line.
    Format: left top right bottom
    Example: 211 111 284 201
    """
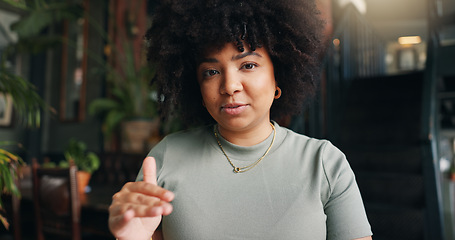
121 119 159 153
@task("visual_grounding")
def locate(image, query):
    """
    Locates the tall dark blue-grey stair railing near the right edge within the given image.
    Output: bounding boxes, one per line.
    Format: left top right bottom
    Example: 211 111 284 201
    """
421 0 455 240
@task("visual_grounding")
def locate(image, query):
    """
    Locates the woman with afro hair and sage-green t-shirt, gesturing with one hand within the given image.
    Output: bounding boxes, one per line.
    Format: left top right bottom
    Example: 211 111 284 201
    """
109 0 372 239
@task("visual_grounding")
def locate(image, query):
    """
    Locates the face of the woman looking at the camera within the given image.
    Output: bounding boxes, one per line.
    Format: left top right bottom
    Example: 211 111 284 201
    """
197 43 276 135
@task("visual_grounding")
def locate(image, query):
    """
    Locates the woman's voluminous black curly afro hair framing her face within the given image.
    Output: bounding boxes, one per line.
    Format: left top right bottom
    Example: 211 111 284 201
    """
145 0 323 125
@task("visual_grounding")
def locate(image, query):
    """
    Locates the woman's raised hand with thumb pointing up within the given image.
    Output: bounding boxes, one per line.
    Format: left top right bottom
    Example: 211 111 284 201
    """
109 157 174 240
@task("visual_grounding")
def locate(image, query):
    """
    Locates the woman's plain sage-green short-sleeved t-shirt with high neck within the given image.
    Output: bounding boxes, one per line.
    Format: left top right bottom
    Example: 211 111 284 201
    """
138 123 372 240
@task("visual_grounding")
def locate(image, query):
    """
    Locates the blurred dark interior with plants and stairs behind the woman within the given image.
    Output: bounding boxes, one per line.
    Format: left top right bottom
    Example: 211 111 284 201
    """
0 0 455 240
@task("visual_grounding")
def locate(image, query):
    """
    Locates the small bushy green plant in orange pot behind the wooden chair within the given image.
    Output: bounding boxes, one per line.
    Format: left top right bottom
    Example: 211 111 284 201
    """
59 138 100 193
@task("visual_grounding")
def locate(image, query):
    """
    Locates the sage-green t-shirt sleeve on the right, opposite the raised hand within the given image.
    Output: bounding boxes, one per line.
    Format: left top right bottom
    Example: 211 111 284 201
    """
322 142 372 240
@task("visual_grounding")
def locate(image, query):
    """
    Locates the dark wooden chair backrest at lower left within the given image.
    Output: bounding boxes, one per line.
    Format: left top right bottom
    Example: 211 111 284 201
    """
33 162 81 240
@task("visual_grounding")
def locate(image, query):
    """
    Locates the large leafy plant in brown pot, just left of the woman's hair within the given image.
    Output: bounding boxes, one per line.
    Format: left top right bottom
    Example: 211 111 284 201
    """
88 43 159 153
